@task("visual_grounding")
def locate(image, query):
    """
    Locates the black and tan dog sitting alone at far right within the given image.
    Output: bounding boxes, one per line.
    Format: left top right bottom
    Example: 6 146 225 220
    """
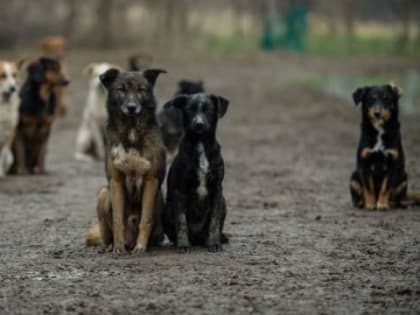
350 84 407 209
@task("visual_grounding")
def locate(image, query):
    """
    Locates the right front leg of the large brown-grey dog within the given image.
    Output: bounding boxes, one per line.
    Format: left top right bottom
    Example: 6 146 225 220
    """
135 177 159 252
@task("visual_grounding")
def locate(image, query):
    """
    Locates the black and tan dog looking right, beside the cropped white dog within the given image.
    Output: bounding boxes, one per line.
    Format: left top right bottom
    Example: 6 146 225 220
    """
11 57 70 174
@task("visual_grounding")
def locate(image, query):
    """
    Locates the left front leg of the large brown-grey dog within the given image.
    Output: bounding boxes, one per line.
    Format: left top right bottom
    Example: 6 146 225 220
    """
111 169 125 254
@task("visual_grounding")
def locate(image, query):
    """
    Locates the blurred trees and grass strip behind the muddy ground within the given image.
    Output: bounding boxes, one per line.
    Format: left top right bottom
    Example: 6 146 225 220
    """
0 0 420 57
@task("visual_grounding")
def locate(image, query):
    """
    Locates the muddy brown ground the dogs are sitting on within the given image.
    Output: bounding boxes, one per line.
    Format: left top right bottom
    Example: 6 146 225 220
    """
0 53 420 315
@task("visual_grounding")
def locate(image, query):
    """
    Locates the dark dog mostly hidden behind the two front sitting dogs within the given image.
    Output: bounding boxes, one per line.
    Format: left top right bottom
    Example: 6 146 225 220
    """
158 80 204 161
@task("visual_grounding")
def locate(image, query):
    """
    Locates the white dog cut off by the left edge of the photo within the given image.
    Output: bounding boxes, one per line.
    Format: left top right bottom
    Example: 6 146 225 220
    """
0 61 22 178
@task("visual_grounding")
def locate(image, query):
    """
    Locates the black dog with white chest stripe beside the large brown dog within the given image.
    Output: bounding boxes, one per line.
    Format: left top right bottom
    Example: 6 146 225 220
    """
164 93 229 253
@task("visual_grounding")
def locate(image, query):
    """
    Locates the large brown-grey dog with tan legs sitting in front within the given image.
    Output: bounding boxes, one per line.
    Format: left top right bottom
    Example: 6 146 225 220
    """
86 69 166 253
